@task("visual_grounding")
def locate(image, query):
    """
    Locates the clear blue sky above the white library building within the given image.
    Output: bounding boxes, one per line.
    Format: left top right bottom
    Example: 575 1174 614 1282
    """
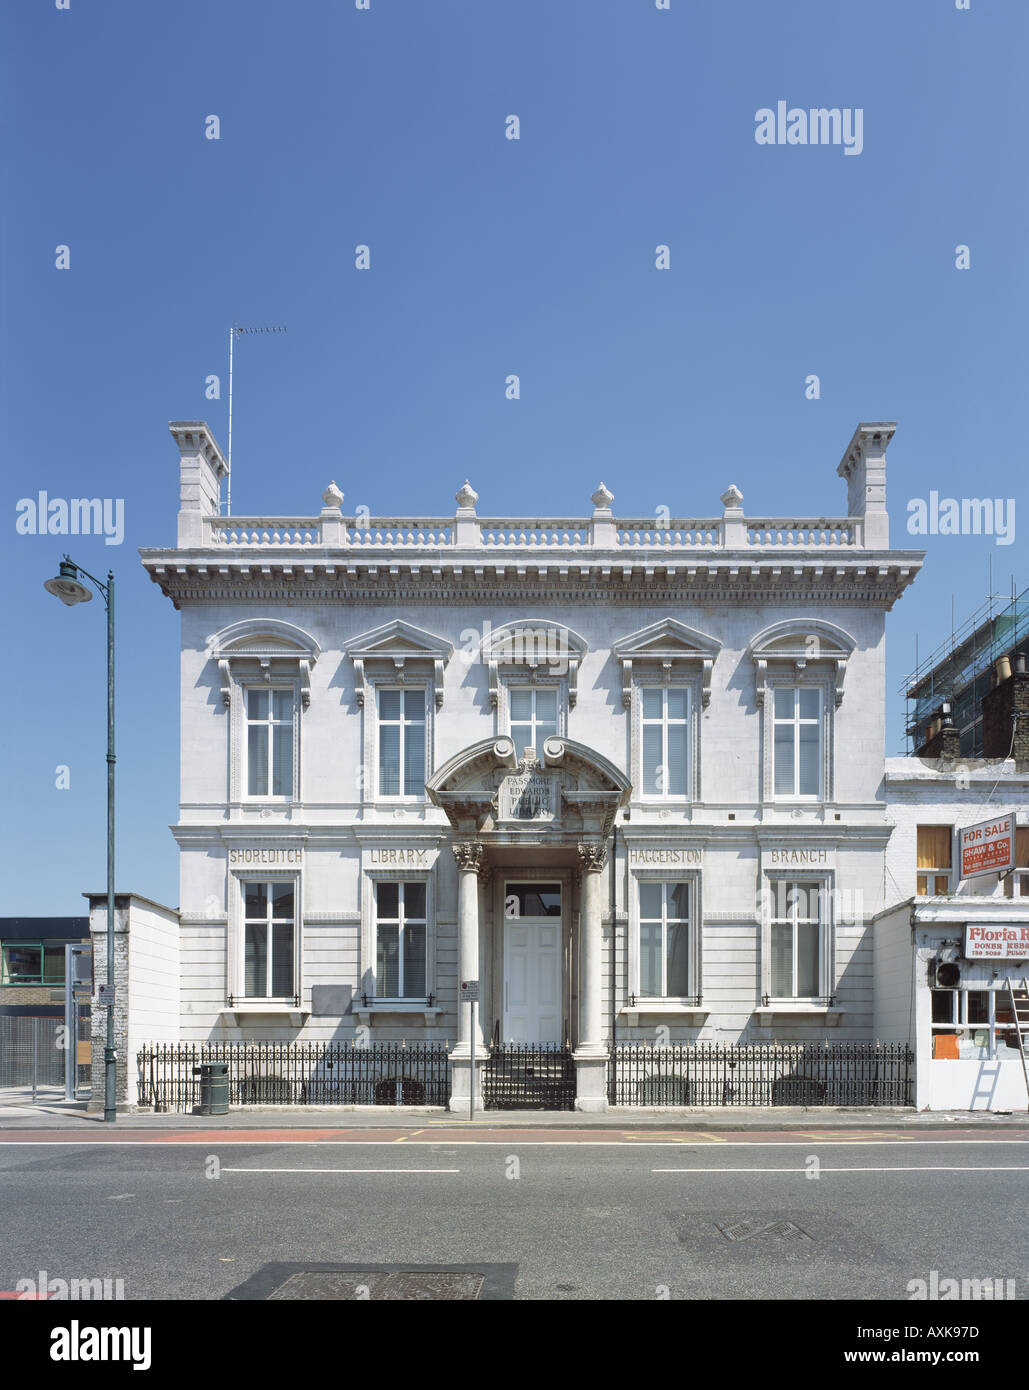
0 0 1029 915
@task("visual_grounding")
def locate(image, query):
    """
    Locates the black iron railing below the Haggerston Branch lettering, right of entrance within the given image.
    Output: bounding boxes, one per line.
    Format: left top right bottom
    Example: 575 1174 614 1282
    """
608 1043 914 1105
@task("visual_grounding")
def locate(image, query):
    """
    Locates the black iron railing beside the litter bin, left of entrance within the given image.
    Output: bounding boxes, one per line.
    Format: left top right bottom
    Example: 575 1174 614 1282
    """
136 1043 451 1111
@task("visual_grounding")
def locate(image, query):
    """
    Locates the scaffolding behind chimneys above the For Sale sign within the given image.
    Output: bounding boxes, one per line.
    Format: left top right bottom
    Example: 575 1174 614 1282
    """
901 589 1029 758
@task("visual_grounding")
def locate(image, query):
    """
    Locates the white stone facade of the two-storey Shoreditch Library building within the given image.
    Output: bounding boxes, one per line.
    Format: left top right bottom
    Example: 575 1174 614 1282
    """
126 423 940 1109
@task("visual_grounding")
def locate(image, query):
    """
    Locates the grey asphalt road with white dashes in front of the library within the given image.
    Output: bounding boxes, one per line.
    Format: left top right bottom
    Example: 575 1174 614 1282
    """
0 1134 1029 1300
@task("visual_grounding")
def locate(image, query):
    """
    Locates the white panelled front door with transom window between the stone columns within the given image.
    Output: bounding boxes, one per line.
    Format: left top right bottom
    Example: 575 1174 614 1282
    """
502 884 562 1043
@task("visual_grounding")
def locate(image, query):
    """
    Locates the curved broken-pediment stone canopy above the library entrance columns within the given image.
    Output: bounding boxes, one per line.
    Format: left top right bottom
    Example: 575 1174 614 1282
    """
426 737 631 847
